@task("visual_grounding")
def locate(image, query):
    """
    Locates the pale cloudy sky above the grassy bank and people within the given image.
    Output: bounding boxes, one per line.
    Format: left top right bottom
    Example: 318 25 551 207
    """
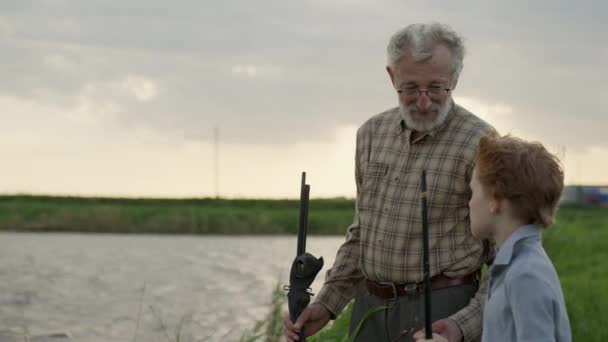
0 0 608 198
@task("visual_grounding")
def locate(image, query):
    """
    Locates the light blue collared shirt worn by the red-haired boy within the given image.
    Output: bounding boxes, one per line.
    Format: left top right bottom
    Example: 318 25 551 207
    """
481 225 572 342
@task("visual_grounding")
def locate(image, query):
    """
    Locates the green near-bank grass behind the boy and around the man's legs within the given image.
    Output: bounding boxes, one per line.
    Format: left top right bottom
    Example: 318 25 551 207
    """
243 208 608 342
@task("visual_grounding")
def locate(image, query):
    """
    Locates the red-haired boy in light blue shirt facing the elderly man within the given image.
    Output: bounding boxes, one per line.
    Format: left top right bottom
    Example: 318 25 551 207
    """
414 135 572 342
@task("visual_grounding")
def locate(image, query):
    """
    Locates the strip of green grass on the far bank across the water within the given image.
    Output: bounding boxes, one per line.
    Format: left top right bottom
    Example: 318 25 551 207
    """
0 196 354 235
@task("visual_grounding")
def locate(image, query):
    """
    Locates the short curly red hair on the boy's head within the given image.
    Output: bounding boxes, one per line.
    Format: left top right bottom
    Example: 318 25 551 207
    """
477 133 564 228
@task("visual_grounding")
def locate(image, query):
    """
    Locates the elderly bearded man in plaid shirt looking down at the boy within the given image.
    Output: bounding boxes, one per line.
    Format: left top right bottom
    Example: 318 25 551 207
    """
285 24 493 341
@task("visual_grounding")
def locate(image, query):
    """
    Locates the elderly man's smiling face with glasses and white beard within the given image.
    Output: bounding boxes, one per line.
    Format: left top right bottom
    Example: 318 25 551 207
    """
387 45 456 132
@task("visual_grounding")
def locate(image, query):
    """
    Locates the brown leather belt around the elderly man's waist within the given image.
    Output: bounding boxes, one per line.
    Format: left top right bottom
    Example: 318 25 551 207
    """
367 272 478 299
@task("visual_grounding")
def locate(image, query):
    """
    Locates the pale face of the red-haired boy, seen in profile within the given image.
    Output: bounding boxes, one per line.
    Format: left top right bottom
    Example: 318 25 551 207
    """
469 168 494 239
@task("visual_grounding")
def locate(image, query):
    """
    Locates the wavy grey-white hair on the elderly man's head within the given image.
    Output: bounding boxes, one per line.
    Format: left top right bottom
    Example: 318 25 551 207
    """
386 23 465 80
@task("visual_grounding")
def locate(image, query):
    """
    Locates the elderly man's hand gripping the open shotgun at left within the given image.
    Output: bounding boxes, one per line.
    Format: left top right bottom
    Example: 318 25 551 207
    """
284 303 331 342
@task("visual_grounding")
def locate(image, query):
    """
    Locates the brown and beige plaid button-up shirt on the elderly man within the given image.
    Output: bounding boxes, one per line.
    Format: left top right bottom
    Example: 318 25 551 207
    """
316 104 493 341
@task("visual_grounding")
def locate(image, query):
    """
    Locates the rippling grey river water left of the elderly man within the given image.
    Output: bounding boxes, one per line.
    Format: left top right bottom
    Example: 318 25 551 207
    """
0 233 344 342
